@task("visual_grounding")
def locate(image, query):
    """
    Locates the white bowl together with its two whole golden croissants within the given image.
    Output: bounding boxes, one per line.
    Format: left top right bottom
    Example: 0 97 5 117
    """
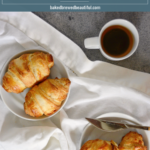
0 50 71 121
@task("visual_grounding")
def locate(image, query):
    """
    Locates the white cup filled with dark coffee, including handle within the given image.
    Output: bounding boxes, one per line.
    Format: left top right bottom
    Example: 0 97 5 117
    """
84 19 139 61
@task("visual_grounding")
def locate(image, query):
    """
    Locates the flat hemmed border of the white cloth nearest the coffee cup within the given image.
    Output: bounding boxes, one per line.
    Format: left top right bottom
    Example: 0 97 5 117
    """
0 12 150 95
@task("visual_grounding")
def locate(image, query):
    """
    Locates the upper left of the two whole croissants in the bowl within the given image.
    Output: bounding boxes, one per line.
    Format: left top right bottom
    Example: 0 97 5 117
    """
2 52 54 93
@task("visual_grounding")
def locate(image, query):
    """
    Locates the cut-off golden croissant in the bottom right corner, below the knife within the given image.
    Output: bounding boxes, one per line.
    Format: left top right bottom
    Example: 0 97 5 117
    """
119 132 147 150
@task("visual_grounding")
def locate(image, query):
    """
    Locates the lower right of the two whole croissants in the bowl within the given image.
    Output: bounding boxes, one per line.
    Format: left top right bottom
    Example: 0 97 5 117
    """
24 78 71 117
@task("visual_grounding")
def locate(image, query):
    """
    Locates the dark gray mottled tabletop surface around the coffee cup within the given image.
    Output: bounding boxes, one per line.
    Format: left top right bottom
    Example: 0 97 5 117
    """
34 12 150 73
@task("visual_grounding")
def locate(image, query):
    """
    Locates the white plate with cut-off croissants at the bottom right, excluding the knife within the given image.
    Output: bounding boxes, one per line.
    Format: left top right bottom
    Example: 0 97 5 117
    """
79 113 150 150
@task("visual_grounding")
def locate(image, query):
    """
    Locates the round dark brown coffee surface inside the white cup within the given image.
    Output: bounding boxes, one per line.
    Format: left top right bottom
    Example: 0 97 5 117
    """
100 25 134 57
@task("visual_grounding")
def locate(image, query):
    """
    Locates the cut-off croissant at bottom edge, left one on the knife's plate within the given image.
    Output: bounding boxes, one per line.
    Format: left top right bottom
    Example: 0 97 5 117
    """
80 139 118 150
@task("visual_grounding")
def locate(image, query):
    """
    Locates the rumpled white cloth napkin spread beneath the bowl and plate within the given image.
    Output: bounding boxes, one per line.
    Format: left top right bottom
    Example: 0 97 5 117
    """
0 12 150 150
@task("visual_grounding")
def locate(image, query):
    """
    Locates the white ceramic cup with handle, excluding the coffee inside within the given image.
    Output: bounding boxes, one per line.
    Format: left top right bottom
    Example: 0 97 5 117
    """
84 19 139 61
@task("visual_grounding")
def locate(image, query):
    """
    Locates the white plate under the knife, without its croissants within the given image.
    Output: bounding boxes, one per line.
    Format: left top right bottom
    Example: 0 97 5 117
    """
79 113 150 149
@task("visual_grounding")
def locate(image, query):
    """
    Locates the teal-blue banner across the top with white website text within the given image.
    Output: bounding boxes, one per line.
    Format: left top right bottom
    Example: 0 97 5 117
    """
0 0 150 12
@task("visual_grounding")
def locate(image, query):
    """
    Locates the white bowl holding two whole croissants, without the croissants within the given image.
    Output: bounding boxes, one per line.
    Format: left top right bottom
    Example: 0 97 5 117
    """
0 50 70 121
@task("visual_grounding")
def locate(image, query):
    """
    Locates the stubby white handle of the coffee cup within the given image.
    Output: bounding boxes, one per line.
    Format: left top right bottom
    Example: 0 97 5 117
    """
84 37 100 49
